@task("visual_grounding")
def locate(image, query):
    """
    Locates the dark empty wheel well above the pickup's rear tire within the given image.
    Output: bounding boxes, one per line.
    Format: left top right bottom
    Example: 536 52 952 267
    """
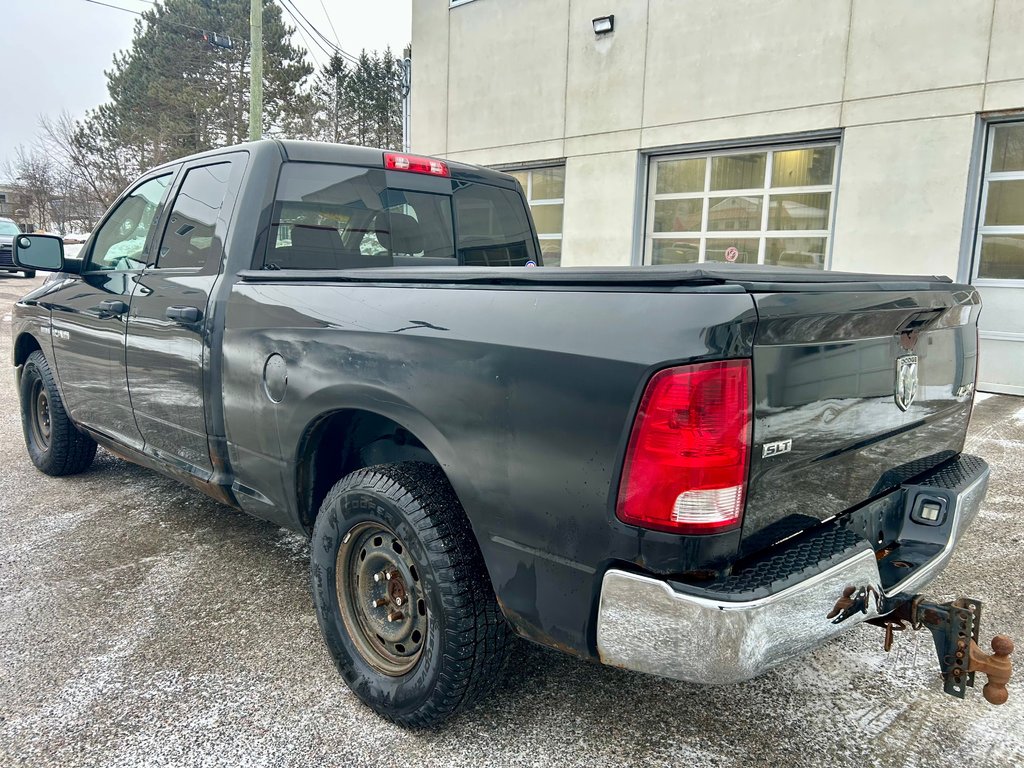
297 411 439 529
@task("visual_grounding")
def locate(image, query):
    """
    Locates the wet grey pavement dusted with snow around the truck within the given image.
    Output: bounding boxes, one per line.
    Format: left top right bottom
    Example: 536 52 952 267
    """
0 276 1024 767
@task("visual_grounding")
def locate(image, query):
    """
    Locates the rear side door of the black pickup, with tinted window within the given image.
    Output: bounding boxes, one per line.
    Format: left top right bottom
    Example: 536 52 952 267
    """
126 155 244 479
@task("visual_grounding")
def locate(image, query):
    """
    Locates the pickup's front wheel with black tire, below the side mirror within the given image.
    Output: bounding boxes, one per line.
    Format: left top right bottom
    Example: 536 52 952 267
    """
22 350 96 477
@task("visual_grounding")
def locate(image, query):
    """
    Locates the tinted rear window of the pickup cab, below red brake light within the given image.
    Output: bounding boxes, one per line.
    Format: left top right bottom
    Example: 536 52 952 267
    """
265 163 539 269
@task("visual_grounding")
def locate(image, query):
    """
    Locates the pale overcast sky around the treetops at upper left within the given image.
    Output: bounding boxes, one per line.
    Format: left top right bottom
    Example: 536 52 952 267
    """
0 0 413 166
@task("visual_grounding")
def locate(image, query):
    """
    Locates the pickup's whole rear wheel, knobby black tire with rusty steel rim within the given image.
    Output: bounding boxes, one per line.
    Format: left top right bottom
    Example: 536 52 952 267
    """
310 462 512 728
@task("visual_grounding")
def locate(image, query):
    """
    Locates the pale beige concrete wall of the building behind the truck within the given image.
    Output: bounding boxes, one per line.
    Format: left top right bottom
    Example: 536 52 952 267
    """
413 0 1024 275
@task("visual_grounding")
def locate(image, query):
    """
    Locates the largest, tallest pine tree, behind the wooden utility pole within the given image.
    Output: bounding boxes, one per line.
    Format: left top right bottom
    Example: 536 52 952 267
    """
80 0 312 182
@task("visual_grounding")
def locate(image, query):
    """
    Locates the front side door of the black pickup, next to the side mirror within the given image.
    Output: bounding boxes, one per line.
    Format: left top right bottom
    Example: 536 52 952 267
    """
46 171 174 449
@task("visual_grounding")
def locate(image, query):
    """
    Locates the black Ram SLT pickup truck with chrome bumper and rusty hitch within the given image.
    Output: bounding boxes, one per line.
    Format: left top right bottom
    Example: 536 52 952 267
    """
13 141 1012 726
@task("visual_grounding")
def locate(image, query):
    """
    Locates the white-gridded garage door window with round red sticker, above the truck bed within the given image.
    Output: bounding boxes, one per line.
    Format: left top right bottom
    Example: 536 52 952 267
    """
644 143 838 269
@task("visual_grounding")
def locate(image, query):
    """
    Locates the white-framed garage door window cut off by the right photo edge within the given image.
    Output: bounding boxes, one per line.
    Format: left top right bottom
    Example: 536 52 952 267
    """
975 123 1024 281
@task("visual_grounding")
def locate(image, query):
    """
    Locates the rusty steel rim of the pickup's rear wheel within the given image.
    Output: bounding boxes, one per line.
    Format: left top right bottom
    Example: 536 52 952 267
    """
335 522 427 677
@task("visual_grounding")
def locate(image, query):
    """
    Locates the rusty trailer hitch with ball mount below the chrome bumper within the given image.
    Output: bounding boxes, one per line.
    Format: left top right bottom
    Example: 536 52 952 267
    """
872 595 1014 705
